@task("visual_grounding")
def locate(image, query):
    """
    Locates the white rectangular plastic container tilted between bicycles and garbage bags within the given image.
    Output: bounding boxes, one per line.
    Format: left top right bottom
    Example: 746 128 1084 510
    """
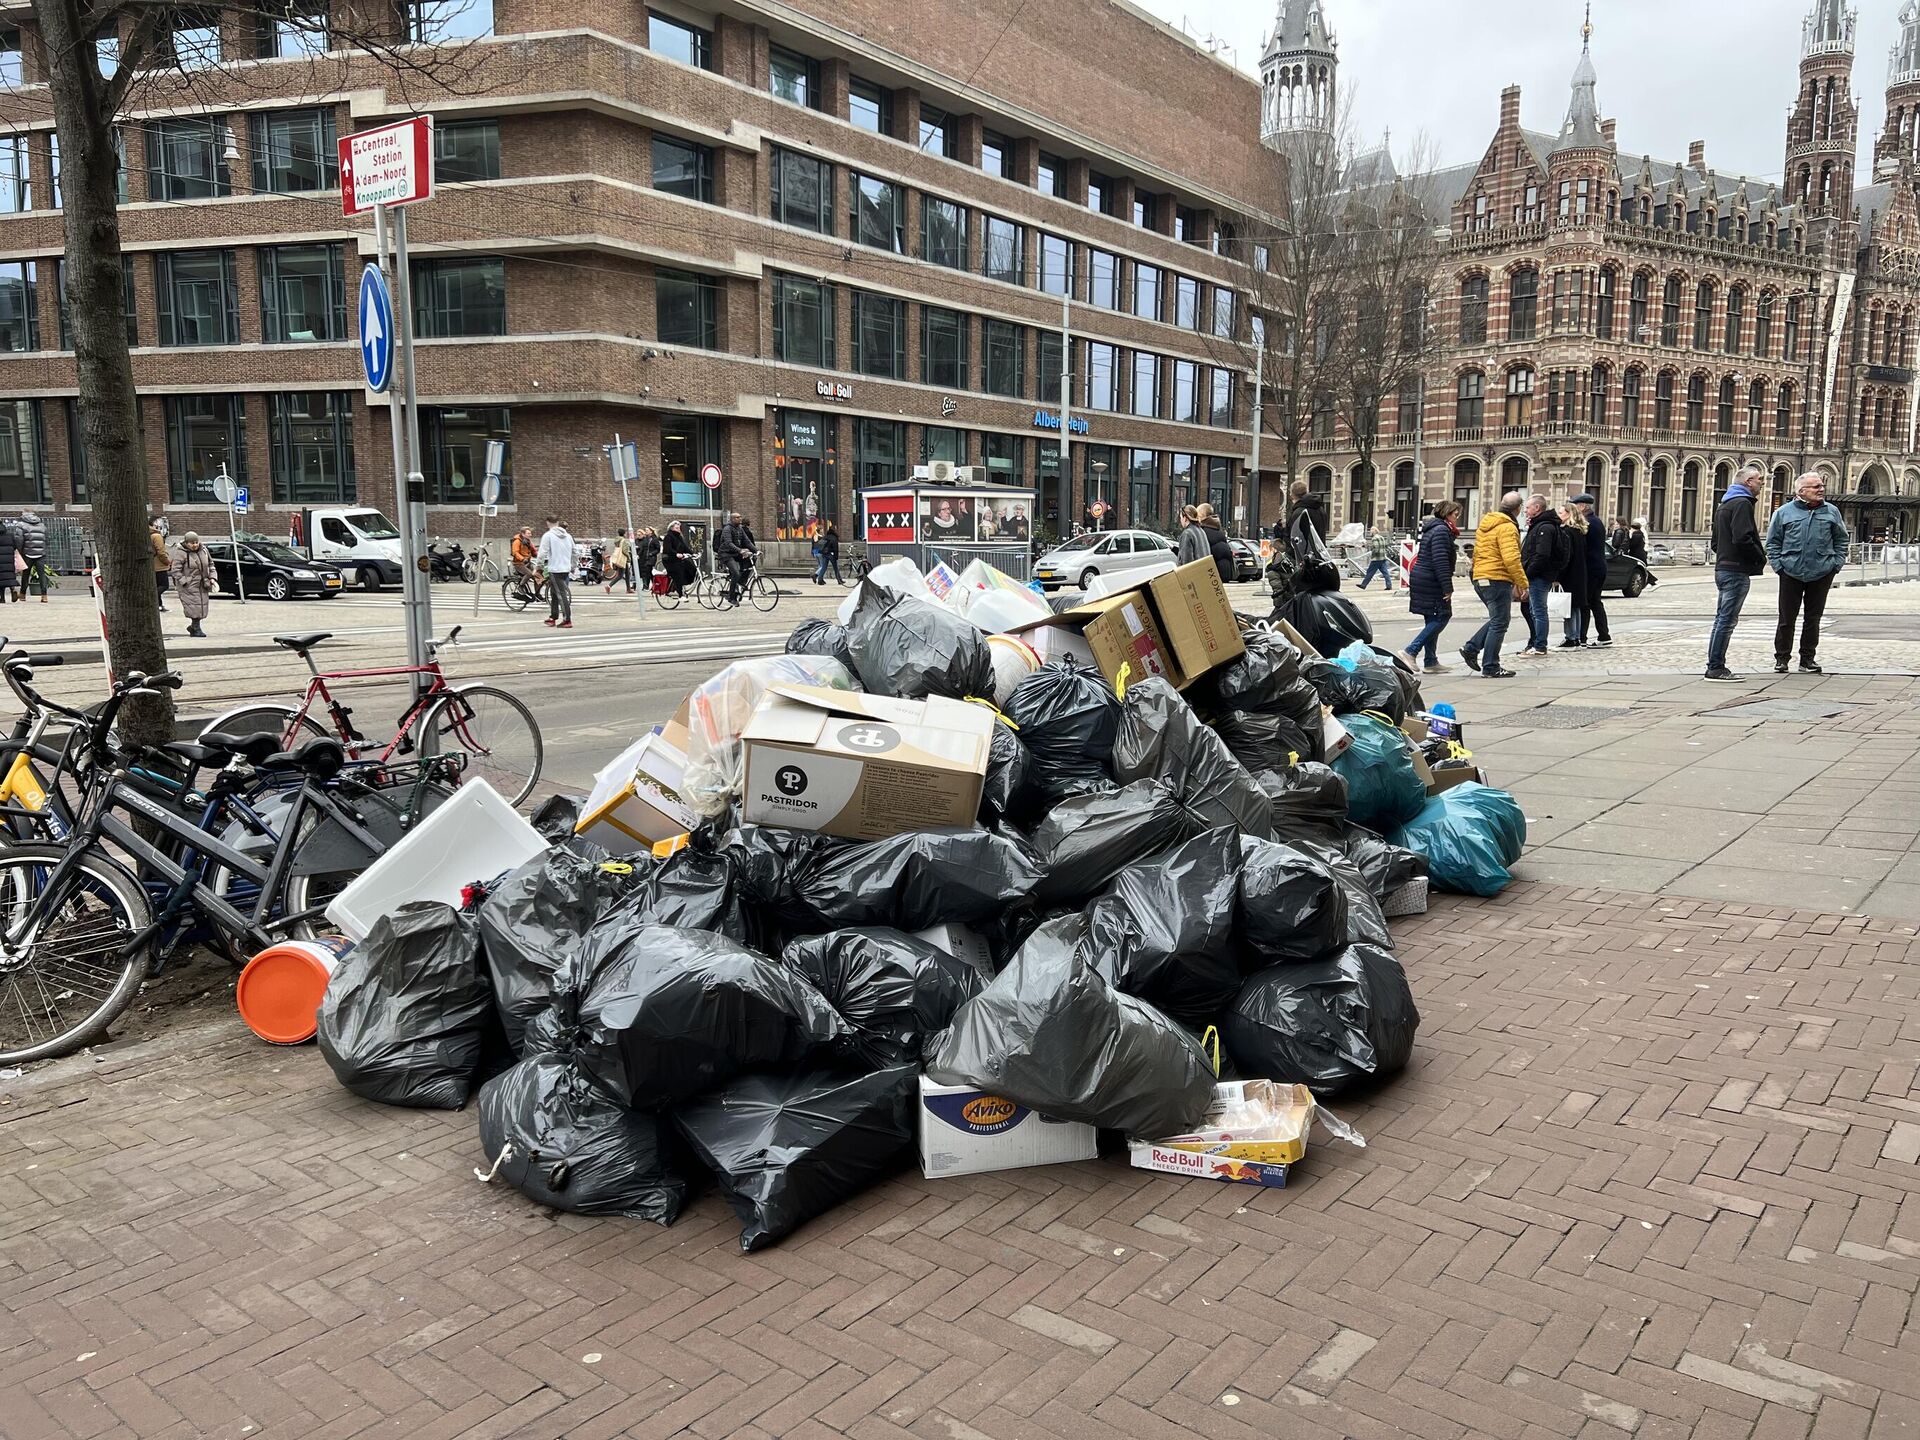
326 780 547 941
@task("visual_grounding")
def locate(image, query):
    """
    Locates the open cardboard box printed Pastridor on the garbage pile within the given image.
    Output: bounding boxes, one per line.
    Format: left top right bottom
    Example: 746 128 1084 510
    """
741 685 996 839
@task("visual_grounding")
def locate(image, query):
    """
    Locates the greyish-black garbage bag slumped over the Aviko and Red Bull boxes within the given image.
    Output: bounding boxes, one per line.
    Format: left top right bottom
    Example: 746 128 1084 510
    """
927 916 1213 1139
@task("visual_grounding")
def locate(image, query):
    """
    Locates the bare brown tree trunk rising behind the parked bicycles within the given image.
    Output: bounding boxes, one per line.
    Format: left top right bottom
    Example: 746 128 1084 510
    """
33 0 173 743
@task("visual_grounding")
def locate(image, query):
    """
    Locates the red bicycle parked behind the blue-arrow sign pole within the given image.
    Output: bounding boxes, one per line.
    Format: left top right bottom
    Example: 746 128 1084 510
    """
202 626 545 804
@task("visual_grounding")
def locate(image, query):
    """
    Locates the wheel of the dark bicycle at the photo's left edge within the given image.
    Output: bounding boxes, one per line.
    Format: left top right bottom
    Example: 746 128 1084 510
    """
0 845 152 1066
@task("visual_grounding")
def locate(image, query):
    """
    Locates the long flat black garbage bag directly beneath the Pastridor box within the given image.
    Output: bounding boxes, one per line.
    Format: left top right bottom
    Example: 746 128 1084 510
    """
728 826 1041 935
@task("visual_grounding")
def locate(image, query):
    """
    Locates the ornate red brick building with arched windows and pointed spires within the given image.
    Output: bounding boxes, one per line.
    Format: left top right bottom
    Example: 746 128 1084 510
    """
1269 0 1920 538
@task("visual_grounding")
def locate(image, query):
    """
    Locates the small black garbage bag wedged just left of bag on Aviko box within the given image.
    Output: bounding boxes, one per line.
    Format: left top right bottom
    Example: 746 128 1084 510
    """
780 925 987 1066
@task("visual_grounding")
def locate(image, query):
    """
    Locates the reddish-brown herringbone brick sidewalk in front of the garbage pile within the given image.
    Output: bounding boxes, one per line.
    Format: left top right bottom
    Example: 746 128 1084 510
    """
0 885 1920 1440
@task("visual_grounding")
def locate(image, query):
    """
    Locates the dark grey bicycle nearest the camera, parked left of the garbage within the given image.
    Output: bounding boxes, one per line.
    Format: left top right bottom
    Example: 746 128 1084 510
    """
0 672 459 1064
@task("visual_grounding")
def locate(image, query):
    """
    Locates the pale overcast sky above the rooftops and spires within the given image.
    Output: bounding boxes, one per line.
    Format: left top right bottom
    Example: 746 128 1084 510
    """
1135 0 1901 180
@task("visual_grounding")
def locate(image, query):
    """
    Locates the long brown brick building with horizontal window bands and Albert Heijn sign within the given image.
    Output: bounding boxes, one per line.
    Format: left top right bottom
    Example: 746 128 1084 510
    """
0 0 1283 556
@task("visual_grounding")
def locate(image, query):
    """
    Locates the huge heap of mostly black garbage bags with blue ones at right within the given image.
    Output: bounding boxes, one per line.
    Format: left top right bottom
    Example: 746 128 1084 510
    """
319 560 1524 1250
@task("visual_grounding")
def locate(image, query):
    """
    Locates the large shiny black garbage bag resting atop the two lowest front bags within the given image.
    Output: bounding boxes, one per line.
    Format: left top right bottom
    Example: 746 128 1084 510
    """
526 924 854 1110
